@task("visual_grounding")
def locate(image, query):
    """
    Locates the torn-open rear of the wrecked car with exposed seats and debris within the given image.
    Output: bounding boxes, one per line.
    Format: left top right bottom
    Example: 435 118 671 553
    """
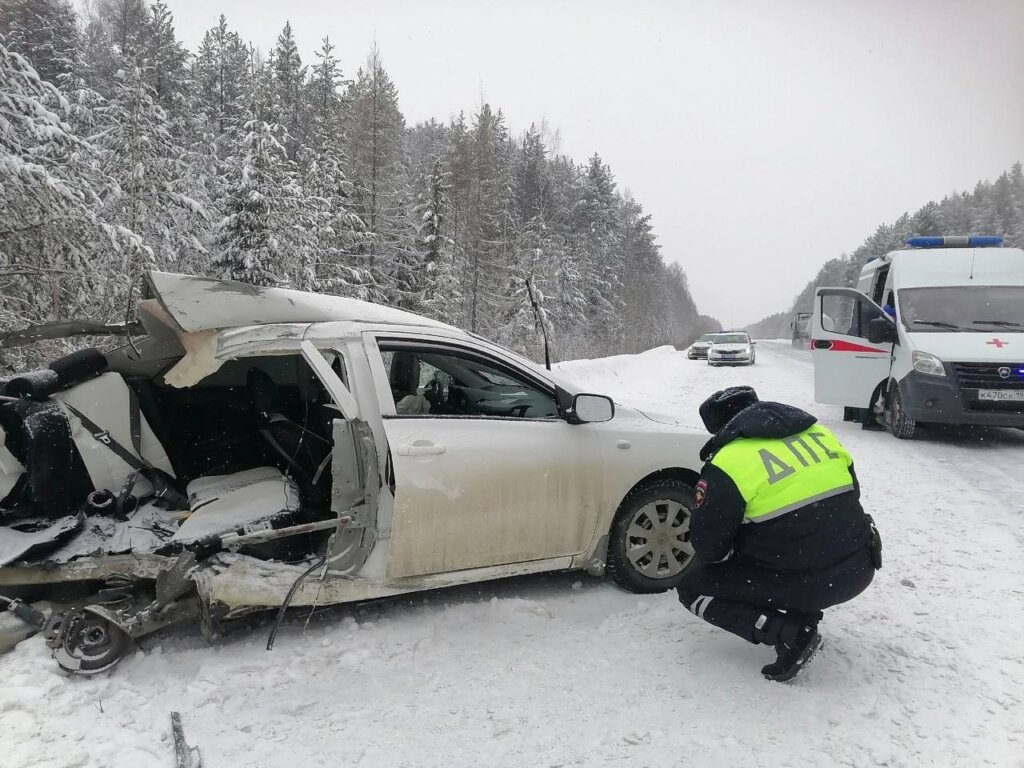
0 280 377 674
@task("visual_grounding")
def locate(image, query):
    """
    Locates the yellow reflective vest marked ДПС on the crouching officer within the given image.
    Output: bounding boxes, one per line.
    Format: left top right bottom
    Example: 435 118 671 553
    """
711 424 853 523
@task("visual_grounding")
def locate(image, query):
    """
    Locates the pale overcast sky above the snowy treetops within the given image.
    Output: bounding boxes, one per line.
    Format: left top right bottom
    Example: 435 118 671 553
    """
159 0 1024 326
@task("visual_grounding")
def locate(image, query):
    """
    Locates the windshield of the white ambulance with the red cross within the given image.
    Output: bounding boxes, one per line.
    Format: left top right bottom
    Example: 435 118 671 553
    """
898 286 1024 333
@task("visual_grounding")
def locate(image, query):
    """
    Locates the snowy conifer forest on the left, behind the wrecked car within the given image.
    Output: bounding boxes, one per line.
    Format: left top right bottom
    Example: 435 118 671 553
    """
0 0 717 372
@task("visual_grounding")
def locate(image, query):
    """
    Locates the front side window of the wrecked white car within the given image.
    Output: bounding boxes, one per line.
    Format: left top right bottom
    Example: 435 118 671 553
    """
381 344 559 419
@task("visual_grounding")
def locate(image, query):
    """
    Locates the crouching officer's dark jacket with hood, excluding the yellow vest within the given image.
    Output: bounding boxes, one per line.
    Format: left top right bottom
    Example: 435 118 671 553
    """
690 401 869 570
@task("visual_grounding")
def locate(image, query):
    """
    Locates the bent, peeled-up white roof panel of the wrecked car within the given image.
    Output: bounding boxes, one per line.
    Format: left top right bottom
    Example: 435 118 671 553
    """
147 271 455 333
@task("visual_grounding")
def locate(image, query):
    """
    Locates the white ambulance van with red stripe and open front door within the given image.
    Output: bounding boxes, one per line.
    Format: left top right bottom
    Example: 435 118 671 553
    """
811 236 1024 439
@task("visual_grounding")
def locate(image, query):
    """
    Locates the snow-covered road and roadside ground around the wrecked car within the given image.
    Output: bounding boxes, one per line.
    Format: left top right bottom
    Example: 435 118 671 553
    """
0 342 1024 768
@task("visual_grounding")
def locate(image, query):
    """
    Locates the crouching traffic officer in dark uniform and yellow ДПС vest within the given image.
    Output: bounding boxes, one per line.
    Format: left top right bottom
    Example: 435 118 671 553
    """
678 387 882 681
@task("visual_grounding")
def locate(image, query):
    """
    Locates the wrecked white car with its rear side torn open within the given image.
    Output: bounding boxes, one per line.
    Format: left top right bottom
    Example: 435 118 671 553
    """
0 272 706 673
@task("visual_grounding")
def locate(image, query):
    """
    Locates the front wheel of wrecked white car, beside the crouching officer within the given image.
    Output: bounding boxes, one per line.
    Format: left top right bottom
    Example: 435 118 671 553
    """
606 478 694 594
